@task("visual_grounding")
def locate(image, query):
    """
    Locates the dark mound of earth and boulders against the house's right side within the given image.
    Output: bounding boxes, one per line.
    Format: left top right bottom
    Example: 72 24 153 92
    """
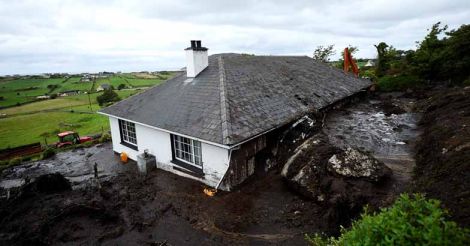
282 134 391 232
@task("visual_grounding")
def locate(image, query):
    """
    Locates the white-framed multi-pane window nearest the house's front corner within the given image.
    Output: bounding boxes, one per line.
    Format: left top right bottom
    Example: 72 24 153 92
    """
173 135 202 167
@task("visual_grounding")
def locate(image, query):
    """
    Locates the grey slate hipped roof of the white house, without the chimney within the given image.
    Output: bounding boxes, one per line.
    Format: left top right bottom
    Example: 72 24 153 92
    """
101 54 371 145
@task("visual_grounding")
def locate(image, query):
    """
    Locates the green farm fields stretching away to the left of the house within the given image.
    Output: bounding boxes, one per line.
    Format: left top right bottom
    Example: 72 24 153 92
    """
0 73 173 149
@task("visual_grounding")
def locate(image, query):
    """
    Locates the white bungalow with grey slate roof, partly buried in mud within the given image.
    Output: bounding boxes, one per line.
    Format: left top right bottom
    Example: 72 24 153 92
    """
99 41 371 190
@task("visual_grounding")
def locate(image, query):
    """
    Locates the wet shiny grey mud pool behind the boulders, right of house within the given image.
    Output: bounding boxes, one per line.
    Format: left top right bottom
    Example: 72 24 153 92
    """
323 98 421 183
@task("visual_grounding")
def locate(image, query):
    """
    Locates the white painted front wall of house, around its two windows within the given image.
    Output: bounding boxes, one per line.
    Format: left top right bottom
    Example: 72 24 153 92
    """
109 117 229 190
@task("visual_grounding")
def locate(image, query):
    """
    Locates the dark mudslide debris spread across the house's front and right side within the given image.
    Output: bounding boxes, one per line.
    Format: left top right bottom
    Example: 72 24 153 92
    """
0 92 424 245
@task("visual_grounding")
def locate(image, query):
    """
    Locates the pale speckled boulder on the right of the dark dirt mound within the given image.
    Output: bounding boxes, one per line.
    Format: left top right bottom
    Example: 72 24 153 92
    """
327 147 391 182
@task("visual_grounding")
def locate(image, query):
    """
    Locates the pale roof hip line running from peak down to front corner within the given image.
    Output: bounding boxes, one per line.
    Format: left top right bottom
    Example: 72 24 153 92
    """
217 56 232 144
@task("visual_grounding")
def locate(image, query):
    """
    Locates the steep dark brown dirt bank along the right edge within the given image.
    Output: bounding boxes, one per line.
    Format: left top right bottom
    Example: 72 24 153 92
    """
414 87 470 226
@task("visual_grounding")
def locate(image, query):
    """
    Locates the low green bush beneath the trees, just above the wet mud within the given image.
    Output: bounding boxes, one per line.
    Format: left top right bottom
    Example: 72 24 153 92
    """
377 75 423 91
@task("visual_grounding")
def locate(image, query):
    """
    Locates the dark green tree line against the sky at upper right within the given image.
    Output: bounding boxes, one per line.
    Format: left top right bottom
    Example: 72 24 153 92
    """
313 22 470 90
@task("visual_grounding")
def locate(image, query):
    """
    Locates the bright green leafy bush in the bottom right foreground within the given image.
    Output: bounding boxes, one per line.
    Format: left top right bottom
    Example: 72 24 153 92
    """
306 194 470 245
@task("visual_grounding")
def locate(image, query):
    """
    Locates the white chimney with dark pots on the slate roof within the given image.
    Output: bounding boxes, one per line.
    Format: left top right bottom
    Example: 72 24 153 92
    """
185 40 209 78
